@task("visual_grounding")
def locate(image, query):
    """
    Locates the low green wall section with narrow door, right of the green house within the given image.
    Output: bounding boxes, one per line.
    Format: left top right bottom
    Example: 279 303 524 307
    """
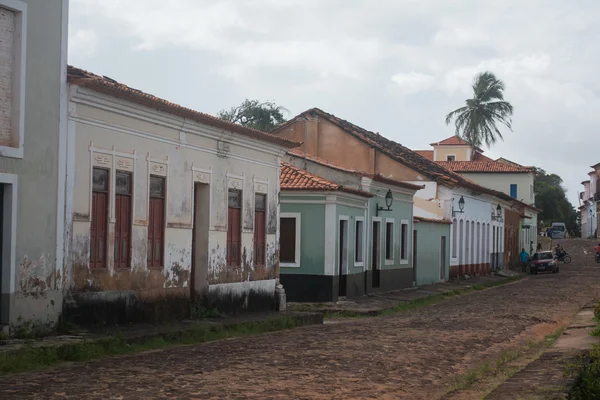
414 222 450 286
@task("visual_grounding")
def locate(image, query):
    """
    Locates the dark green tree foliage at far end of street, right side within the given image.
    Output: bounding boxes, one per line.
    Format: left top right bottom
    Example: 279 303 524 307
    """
534 167 581 236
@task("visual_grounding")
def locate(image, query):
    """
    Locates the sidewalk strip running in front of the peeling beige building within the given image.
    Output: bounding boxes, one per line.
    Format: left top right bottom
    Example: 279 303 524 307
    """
0 311 323 353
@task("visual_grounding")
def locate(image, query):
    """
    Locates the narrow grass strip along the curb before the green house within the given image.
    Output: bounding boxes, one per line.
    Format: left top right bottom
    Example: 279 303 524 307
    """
324 275 524 319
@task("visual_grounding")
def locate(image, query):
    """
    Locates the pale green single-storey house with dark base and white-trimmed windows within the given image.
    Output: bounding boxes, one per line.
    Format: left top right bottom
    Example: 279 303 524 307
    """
281 154 424 301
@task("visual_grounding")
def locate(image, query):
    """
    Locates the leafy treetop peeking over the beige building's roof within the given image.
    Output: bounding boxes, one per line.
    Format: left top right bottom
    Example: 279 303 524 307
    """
218 99 288 132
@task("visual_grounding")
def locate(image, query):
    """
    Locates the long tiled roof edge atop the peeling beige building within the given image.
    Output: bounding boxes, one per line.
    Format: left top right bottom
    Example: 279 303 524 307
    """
67 65 300 148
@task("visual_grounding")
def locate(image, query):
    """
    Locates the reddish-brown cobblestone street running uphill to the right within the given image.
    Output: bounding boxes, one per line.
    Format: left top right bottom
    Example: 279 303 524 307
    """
0 240 600 399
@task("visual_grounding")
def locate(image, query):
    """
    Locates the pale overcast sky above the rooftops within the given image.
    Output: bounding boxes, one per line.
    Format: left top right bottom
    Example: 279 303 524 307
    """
69 0 600 206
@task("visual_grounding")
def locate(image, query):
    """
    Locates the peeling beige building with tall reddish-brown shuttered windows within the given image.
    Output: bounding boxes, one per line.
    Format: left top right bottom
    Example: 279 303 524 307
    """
65 67 297 323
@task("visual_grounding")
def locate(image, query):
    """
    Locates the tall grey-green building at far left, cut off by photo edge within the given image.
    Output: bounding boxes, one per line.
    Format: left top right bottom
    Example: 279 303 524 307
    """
0 0 68 326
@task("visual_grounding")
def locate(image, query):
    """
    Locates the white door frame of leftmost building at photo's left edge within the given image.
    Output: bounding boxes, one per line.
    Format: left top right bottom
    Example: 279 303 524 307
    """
0 173 17 324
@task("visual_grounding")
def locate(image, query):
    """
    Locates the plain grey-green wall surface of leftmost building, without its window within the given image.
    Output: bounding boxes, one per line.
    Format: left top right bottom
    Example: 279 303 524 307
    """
0 0 68 324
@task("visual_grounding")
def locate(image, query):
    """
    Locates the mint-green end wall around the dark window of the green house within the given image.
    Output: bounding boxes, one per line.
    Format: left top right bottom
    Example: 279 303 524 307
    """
279 200 325 275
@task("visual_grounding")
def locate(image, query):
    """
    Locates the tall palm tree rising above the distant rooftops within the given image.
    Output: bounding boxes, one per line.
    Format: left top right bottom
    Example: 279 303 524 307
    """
446 71 513 154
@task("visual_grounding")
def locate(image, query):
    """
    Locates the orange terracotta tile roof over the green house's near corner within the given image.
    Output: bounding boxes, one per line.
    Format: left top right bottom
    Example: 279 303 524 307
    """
279 162 375 197
